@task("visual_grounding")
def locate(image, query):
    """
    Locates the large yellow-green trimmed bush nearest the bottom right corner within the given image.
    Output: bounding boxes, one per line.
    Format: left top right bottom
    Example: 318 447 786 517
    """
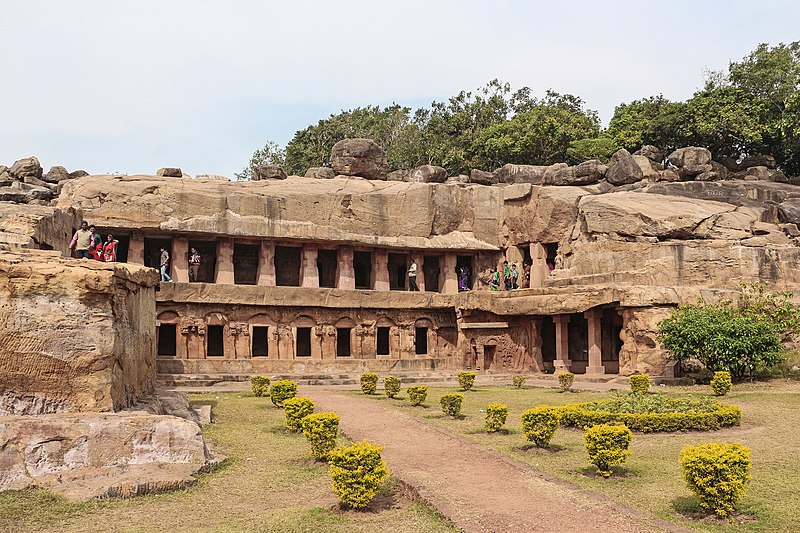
679 442 751 516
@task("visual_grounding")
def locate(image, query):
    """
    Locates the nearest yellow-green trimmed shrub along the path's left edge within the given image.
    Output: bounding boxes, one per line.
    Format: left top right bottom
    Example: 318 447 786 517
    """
328 440 389 509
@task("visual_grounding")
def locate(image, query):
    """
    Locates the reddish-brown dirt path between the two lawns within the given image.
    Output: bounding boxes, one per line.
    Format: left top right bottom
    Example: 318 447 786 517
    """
303 387 685 533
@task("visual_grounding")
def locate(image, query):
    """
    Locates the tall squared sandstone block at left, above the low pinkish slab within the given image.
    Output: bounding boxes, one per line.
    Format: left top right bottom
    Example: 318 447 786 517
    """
0 251 158 415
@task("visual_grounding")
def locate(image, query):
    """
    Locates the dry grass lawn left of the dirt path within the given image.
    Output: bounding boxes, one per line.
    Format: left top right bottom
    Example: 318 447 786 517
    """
0 393 454 533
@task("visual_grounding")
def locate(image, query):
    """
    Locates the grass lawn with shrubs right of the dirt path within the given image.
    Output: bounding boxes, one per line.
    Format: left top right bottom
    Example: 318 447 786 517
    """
368 381 800 532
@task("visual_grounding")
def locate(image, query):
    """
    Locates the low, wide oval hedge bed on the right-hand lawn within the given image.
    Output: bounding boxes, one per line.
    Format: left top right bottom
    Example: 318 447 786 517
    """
561 394 742 433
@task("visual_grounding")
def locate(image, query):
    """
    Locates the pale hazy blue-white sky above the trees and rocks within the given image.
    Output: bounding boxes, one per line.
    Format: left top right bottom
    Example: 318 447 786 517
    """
0 0 800 177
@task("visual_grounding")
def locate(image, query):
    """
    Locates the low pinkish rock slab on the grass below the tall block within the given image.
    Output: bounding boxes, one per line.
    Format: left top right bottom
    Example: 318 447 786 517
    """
0 413 221 500
